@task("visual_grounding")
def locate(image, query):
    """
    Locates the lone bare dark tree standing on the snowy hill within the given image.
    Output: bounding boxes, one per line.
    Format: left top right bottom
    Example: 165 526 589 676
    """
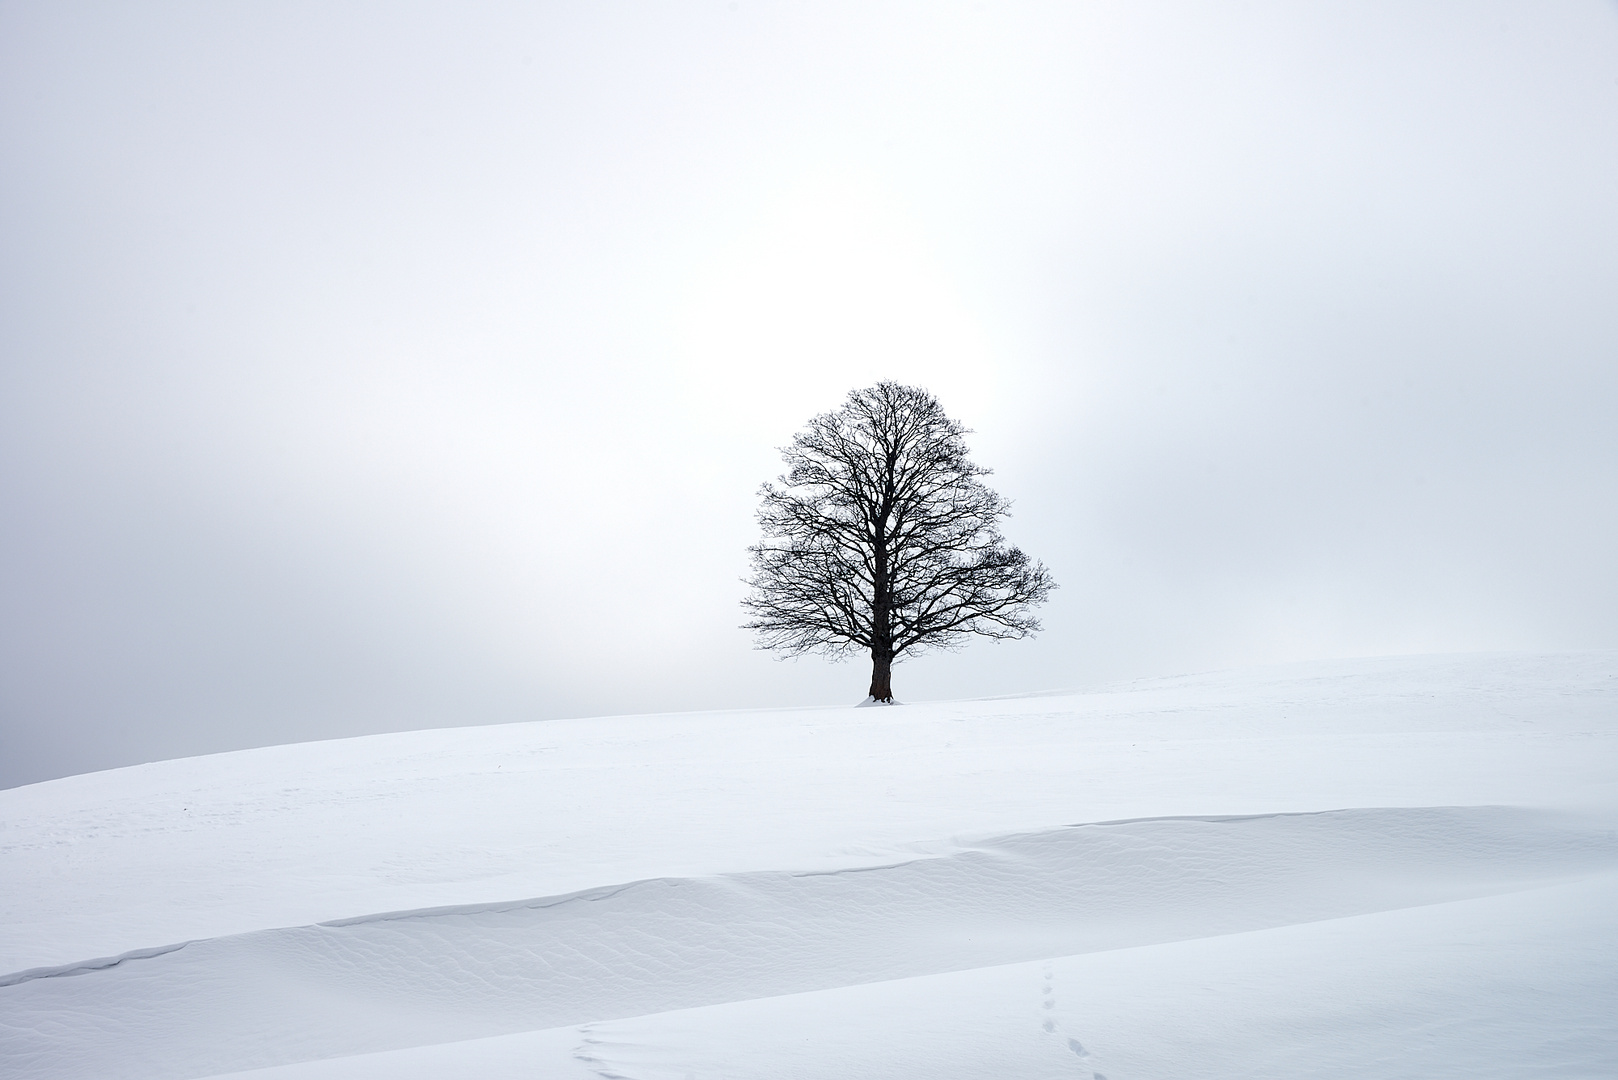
743 382 1057 703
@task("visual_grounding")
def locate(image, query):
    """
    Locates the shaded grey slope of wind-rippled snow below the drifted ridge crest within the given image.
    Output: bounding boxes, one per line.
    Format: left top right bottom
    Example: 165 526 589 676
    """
0 808 1618 1080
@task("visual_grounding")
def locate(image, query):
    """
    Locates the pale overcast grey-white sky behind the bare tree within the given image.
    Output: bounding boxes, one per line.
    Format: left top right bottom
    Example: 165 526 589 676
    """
0 0 1618 785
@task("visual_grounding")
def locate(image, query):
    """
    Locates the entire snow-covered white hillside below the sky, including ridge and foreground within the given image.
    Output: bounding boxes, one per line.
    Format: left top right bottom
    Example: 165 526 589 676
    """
0 653 1618 1080
